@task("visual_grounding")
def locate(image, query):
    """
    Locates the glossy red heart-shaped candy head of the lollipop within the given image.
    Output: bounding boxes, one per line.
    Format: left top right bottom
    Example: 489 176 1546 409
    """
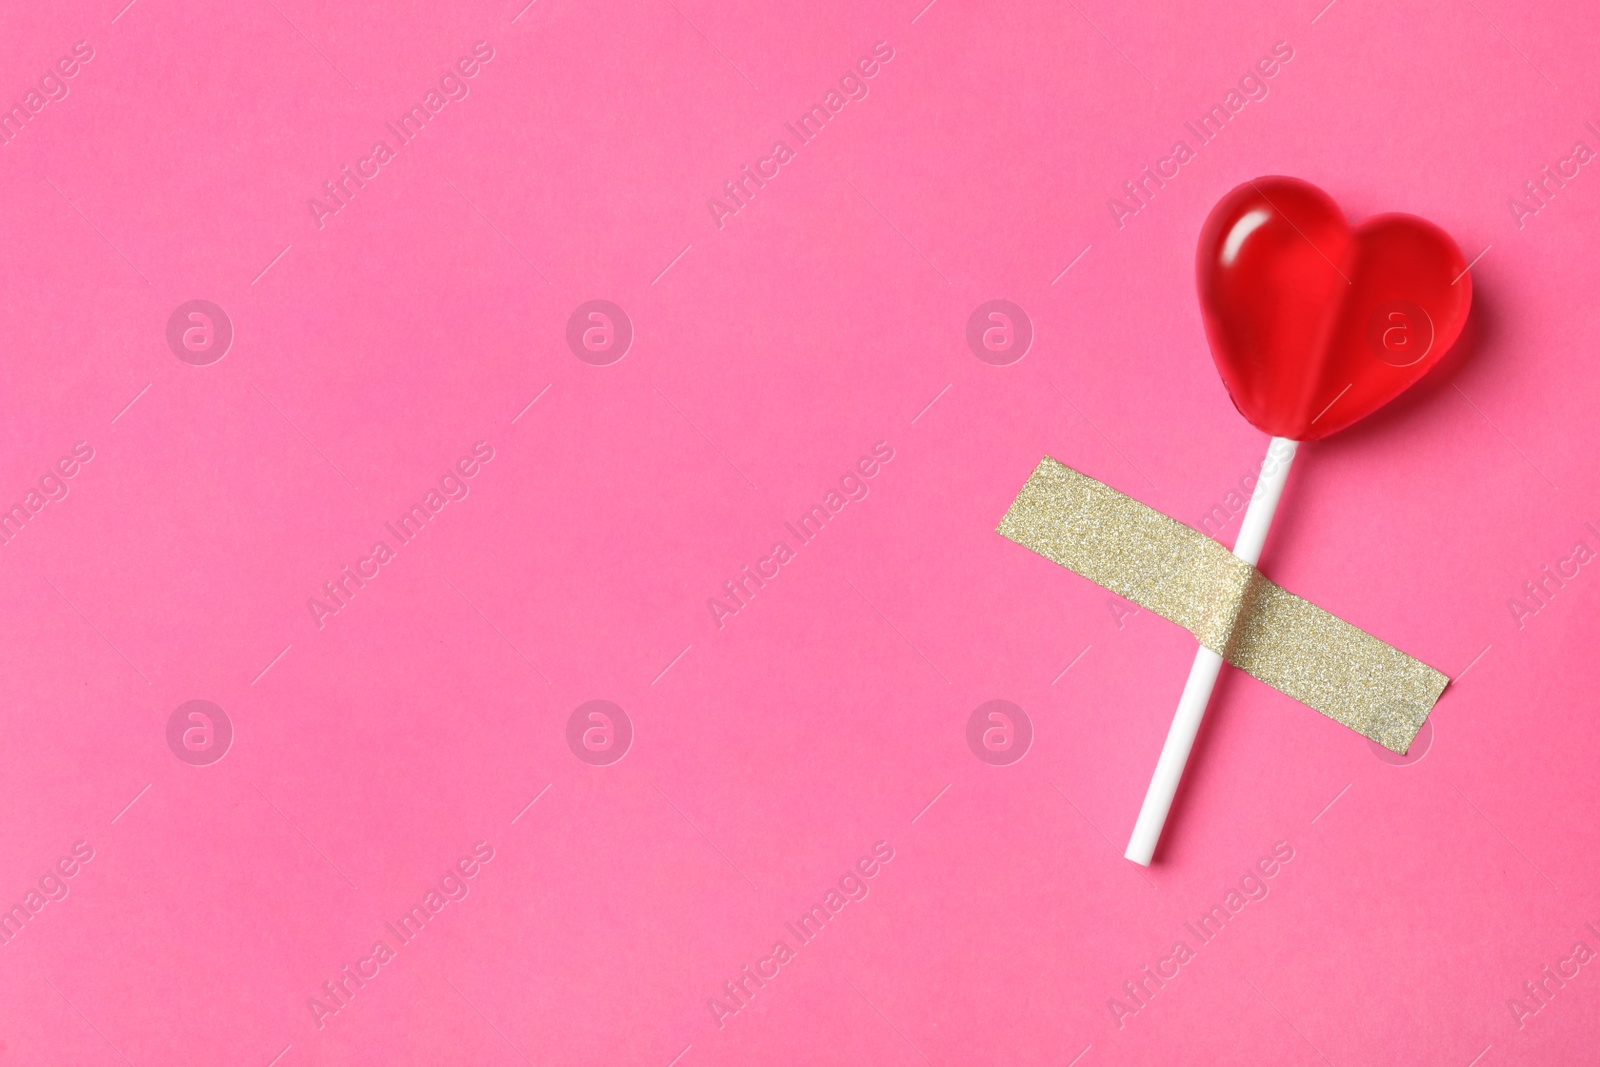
1195 178 1472 442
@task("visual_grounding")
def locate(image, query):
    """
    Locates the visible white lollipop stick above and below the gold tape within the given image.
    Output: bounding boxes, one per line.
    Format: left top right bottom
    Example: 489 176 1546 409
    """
1123 437 1296 867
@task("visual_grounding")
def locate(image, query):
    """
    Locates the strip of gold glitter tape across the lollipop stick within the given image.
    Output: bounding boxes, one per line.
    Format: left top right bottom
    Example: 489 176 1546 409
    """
998 456 1450 753
